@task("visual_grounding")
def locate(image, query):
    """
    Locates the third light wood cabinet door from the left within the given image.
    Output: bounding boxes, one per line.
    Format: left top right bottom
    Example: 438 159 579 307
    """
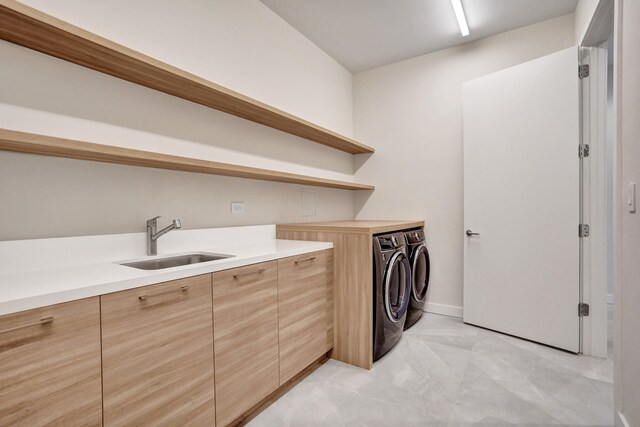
213 261 279 426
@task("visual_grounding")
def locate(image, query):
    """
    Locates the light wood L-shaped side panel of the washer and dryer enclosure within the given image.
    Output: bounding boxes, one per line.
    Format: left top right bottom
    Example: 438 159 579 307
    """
276 226 373 369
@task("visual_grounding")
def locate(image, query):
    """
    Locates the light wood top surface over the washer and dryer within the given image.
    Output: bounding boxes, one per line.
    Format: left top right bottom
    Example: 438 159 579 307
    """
278 220 424 234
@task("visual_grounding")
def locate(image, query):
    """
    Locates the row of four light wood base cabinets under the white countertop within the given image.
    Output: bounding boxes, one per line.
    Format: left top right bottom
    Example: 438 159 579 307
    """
0 249 334 427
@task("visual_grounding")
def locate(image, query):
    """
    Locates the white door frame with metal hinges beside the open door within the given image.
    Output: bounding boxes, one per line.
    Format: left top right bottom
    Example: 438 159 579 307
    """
578 0 620 357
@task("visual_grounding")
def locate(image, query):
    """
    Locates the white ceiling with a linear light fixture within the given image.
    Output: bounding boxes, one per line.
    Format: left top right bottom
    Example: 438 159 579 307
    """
260 0 578 73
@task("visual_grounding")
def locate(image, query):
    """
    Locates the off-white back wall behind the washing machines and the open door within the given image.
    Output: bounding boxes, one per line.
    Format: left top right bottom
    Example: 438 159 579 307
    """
354 15 575 307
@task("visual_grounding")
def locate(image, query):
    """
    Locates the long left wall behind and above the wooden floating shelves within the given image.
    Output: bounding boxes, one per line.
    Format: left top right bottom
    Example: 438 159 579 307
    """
0 0 353 240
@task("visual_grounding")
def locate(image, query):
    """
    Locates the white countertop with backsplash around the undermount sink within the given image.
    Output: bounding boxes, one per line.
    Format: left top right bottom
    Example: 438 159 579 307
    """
0 226 333 315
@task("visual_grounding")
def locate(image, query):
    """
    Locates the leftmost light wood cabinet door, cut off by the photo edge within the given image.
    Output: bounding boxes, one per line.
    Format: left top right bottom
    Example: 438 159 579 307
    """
0 297 102 426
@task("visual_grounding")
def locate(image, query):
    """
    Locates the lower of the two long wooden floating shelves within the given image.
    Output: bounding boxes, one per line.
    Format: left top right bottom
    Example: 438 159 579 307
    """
0 129 375 190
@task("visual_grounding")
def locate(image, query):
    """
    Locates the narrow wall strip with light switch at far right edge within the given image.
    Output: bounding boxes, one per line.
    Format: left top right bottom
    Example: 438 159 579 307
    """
614 0 640 426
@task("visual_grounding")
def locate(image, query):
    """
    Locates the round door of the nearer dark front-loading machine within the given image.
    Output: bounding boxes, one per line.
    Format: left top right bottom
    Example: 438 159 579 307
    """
382 252 411 323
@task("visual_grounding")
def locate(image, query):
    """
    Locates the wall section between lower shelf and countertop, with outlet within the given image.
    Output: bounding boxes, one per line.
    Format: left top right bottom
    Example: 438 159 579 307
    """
0 153 353 240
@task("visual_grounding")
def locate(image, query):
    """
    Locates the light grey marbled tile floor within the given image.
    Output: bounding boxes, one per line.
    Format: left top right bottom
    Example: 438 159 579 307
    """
249 314 613 427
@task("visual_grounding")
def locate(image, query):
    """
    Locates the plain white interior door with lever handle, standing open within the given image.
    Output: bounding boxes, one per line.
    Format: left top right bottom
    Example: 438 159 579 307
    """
462 48 580 352
